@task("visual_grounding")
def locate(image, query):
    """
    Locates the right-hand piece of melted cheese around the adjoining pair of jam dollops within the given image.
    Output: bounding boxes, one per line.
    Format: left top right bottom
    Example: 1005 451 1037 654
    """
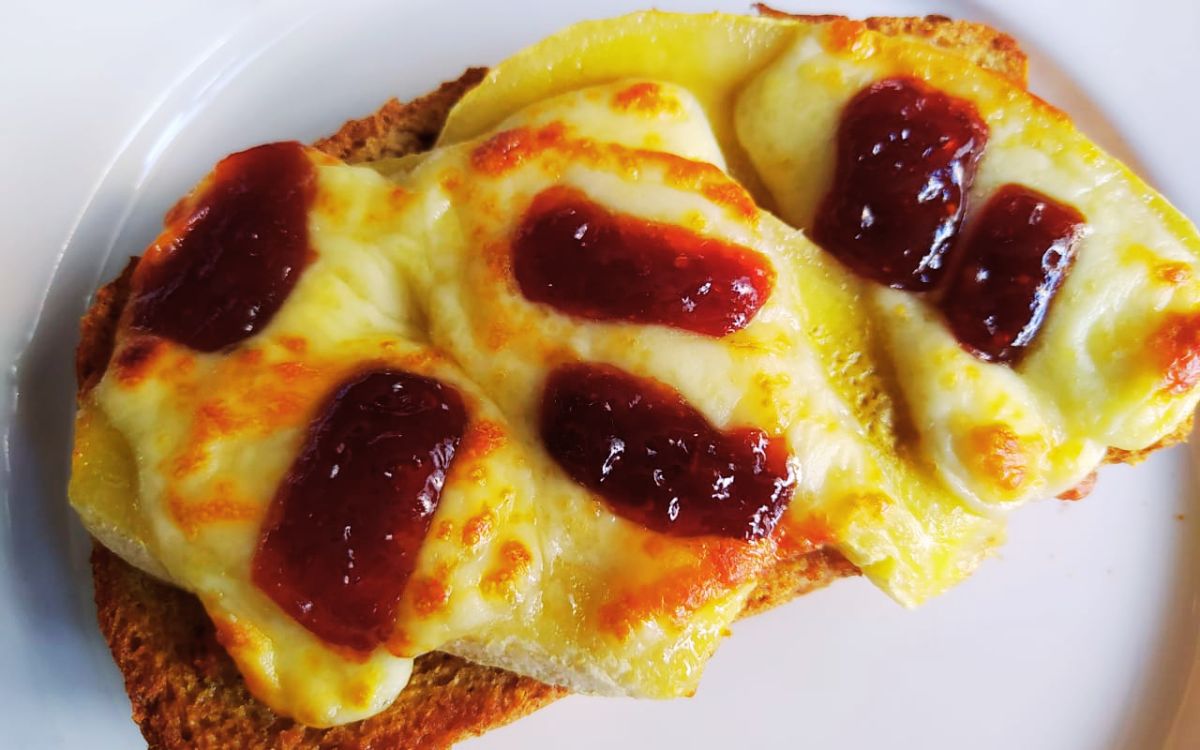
736 24 1200 505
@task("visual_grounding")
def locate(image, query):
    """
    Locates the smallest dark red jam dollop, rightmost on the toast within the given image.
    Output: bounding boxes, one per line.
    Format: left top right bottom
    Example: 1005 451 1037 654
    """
941 185 1087 362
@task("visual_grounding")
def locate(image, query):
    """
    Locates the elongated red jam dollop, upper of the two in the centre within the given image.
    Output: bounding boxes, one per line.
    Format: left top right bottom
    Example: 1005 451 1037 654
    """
512 187 775 336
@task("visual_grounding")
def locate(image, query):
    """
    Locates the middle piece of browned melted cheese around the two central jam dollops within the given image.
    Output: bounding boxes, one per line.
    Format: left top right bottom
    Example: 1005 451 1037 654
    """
410 92 883 697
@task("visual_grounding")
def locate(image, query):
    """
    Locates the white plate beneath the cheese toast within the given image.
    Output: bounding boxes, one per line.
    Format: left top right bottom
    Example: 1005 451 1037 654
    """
0 0 1200 750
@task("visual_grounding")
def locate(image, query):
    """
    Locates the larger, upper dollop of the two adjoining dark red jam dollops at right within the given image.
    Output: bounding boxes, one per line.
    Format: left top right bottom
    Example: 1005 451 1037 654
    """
812 78 988 290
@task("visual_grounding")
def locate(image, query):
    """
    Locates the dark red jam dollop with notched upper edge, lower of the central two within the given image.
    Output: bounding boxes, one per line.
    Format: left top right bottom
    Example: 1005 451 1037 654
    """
540 364 796 540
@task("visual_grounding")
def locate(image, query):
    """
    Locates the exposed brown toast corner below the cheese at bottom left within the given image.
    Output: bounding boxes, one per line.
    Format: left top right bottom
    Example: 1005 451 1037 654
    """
92 545 565 750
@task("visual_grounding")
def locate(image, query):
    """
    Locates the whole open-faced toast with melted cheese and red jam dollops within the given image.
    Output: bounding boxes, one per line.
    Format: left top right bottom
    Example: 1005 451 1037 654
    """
70 12 1200 748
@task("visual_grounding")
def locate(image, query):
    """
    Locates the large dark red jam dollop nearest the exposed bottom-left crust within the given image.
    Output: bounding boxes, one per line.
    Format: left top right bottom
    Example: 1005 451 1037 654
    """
253 370 467 652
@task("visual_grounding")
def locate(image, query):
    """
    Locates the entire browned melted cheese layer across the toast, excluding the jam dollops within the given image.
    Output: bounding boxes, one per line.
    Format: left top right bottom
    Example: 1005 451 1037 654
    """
71 13 1200 726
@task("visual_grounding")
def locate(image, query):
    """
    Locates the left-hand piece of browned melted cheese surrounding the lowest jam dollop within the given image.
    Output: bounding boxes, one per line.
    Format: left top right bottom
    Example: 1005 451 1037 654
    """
72 160 538 726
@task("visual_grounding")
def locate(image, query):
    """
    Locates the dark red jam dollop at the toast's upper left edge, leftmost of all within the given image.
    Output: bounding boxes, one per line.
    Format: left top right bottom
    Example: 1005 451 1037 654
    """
132 143 316 352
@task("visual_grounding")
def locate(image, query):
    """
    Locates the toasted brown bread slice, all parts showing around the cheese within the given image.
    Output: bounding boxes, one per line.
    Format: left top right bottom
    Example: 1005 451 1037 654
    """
77 13 1139 750
